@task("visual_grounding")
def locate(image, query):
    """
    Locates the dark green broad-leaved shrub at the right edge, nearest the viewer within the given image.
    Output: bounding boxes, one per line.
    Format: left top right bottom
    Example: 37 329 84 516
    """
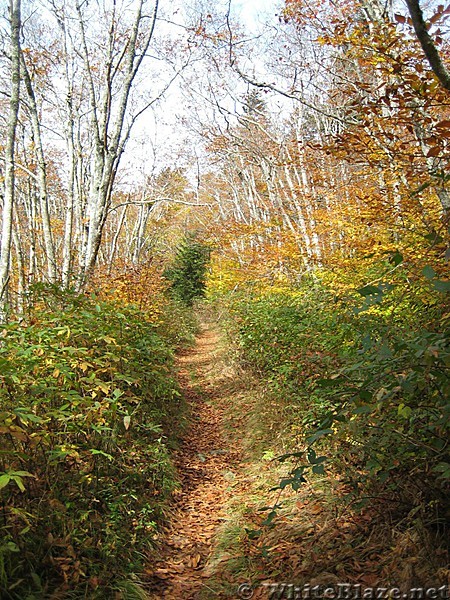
321 318 450 510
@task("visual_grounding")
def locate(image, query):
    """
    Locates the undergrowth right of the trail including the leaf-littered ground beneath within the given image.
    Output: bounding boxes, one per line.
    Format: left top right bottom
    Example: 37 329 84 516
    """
212 258 450 588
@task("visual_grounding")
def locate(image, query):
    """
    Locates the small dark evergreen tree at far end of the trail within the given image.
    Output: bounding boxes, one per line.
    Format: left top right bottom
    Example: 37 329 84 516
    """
164 234 210 306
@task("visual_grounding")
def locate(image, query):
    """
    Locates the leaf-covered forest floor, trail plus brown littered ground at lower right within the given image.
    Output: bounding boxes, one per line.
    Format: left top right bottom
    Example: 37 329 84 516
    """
146 326 450 600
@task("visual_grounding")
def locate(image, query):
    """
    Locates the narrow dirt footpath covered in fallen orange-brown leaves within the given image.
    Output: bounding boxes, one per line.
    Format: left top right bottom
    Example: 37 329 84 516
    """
147 329 246 600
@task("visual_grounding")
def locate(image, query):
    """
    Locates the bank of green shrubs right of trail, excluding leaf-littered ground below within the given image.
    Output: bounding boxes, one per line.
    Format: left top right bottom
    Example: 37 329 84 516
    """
222 281 450 524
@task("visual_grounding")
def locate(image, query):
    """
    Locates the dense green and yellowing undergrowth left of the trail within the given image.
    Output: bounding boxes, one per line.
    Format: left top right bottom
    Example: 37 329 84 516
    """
0 287 191 600
